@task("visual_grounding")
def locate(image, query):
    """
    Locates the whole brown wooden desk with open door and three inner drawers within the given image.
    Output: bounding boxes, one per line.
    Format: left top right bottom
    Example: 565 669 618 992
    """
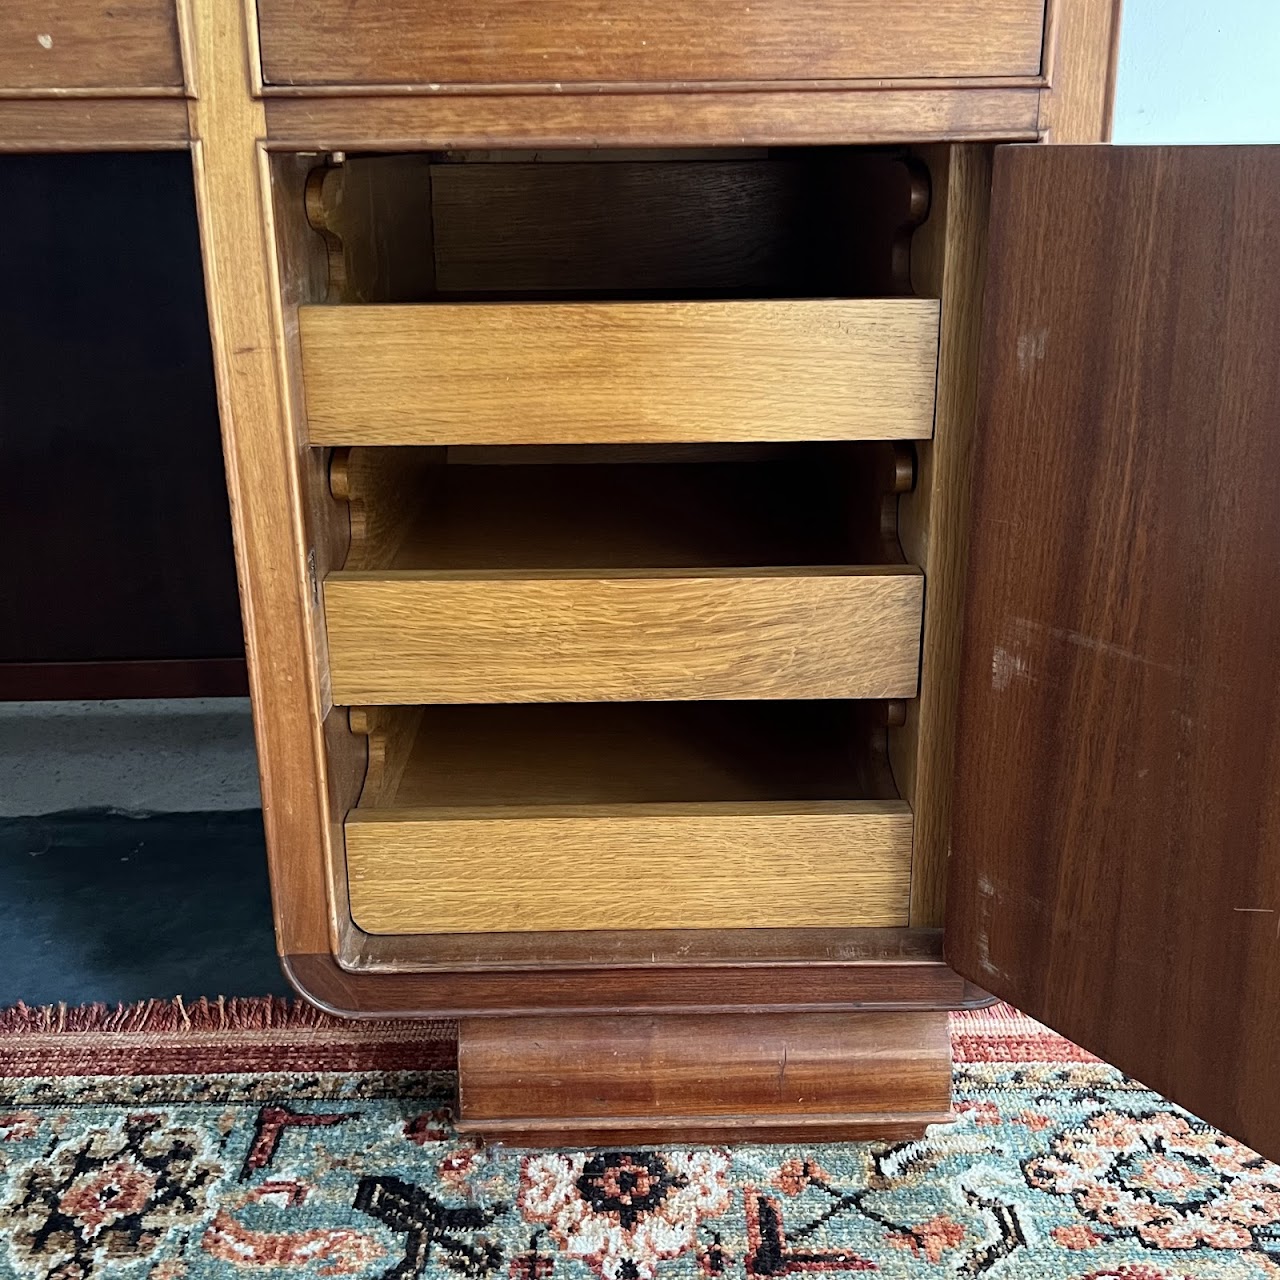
15 0 1280 1155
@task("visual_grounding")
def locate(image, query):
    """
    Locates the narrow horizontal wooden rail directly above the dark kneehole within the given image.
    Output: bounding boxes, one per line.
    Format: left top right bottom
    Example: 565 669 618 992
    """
0 96 191 152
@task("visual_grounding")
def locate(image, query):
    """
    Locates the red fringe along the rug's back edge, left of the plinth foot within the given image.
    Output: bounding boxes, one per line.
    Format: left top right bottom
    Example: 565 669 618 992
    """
0 996 457 1039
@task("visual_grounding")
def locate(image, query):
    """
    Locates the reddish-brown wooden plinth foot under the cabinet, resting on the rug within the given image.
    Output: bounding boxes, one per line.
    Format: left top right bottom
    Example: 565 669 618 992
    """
458 1012 951 1161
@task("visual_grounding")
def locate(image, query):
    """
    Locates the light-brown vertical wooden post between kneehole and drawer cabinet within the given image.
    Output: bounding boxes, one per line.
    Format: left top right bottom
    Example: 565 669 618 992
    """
188 0 335 954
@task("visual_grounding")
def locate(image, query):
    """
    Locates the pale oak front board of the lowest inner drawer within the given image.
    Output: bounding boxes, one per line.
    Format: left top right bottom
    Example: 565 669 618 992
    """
346 800 913 933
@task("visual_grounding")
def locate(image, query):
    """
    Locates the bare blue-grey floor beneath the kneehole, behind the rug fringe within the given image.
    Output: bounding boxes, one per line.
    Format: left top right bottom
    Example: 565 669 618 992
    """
0 699 288 1005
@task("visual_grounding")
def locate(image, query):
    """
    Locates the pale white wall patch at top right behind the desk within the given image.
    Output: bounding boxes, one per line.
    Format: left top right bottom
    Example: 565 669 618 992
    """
1114 0 1280 143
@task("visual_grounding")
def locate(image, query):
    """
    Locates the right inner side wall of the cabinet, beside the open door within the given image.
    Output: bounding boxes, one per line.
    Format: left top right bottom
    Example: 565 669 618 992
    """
890 146 991 928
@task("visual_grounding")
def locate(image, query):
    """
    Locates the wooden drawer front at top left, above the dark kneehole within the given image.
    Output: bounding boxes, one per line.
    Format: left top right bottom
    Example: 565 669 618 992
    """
0 0 183 93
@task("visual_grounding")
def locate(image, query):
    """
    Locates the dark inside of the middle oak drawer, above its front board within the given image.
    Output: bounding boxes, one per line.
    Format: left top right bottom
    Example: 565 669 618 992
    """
333 443 913 572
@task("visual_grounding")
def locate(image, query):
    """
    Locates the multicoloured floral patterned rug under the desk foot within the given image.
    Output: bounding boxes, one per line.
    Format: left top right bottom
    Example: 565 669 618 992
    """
0 1012 1280 1280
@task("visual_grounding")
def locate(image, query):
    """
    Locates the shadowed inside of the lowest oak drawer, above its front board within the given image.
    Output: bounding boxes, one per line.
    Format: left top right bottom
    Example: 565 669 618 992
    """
351 701 897 809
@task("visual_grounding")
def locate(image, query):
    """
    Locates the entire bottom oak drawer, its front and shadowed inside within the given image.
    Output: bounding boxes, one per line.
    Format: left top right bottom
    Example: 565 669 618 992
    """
347 703 913 933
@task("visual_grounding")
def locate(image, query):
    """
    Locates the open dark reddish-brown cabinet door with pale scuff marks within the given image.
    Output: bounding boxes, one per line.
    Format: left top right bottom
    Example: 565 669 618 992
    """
946 146 1280 1158
